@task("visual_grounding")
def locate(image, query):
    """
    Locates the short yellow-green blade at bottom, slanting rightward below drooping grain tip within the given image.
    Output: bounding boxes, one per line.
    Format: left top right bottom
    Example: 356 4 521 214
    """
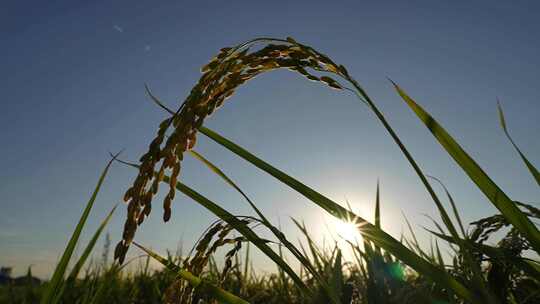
133 242 249 304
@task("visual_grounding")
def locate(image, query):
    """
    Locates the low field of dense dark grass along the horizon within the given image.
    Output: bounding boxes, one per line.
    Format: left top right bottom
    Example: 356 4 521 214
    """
4 207 540 303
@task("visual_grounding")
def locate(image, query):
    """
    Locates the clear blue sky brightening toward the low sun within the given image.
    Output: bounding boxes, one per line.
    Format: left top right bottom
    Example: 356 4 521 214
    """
0 0 540 276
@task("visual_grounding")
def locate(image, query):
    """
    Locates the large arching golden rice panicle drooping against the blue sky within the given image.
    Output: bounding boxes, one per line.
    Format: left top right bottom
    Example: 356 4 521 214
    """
115 38 348 262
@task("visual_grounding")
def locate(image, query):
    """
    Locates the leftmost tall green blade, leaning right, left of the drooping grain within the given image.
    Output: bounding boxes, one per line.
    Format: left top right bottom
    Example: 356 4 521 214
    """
41 153 119 304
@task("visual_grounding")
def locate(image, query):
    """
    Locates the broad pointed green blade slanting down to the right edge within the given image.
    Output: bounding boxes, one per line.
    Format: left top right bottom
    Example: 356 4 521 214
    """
392 82 540 253
